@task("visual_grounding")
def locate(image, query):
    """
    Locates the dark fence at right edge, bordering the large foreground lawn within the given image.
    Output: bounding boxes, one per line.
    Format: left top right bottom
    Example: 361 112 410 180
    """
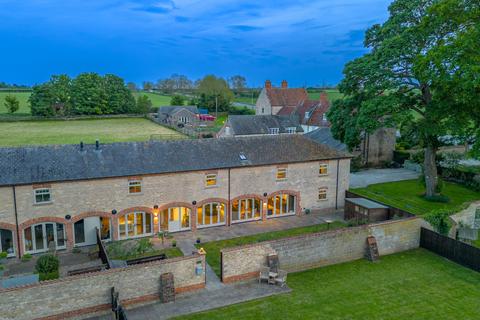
420 228 480 272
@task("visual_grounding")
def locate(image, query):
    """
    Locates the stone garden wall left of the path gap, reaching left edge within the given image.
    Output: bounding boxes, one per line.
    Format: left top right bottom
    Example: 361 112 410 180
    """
0 255 205 319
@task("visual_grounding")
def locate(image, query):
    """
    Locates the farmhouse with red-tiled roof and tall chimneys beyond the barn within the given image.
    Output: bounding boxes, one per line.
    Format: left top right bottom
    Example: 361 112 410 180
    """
256 80 330 132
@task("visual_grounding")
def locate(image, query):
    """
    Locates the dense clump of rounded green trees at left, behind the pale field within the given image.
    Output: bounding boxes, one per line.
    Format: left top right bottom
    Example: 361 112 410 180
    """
29 73 151 116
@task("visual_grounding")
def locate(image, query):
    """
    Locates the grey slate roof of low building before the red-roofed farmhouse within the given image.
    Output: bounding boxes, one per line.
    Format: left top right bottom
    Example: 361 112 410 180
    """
228 115 303 135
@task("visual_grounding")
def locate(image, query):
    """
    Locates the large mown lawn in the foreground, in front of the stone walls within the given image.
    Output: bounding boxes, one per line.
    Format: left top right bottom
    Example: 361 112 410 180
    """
181 249 480 320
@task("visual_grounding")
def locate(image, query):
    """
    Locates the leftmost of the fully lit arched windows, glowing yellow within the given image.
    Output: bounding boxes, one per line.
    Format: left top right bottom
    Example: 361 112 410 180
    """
118 212 153 239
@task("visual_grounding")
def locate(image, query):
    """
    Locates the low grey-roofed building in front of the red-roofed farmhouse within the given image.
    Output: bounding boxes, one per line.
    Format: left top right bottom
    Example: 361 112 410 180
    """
217 115 303 138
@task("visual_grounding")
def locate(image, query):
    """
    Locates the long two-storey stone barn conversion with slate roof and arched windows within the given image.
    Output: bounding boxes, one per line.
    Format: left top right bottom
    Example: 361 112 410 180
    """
0 134 351 256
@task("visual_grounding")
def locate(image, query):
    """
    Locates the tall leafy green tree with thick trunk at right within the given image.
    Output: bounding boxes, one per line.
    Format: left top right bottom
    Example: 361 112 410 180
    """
328 0 480 196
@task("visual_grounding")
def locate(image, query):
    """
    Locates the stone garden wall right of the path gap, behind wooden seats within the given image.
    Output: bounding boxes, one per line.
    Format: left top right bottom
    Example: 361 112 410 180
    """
221 218 421 283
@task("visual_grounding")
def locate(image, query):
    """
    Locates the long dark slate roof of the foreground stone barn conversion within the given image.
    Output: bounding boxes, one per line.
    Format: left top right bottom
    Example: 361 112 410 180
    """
0 134 349 185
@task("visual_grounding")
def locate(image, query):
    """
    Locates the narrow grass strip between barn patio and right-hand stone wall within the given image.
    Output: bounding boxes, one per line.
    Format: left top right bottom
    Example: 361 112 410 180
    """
196 222 346 277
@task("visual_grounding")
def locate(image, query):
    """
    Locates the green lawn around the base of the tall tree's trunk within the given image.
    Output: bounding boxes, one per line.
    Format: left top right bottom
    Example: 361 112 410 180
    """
352 180 480 216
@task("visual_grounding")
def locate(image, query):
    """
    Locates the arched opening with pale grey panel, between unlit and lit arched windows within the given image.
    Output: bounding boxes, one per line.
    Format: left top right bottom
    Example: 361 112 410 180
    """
73 217 111 246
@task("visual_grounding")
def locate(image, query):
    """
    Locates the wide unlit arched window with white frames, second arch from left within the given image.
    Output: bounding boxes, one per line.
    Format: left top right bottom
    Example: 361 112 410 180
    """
23 222 67 253
